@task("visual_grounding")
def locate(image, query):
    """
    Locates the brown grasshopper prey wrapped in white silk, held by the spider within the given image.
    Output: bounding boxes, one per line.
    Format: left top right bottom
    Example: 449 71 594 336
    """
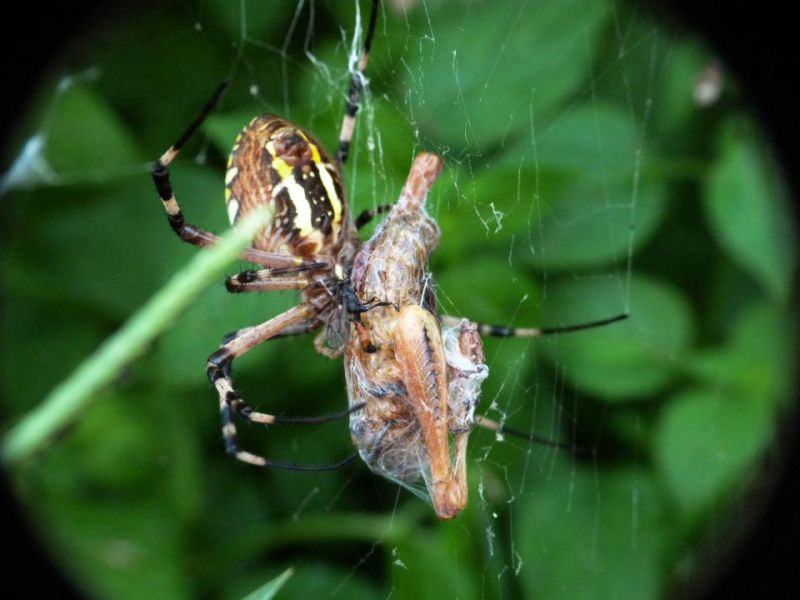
344 153 489 519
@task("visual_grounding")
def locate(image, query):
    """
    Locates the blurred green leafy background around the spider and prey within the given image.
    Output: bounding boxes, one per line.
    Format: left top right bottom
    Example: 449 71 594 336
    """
0 0 797 599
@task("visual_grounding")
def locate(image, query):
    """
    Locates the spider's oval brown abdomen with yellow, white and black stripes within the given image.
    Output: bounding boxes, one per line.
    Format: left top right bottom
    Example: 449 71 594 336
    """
225 115 350 258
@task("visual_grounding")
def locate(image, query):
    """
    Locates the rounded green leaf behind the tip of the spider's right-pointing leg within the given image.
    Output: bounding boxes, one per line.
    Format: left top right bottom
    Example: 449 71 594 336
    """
540 276 694 401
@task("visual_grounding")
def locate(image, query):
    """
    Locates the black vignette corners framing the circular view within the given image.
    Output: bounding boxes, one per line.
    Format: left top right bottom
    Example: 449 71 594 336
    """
0 0 800 598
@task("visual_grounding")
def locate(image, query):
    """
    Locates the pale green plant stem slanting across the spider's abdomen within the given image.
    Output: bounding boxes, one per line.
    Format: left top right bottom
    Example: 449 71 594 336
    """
0 211 269 466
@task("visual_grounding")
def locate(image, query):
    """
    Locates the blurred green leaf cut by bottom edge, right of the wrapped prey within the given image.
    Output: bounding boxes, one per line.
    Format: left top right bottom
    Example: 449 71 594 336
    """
512 462 669 600
